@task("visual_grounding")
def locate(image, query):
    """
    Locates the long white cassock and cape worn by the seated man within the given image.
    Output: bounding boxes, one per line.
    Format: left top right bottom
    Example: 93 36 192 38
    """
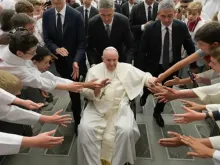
77 63 152 165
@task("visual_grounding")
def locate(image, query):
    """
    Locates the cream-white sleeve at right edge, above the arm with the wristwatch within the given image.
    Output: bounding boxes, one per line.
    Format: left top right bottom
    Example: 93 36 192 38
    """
192 83 220 104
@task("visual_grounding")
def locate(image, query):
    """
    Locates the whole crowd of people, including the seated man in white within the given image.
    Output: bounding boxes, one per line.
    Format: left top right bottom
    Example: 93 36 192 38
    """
0 0 220 165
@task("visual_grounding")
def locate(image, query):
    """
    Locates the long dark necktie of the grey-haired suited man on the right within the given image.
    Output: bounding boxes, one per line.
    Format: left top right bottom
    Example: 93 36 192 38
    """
163 27 170 70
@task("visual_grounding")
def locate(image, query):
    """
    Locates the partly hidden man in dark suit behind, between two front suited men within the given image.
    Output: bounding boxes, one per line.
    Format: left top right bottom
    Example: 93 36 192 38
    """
76 0 98 35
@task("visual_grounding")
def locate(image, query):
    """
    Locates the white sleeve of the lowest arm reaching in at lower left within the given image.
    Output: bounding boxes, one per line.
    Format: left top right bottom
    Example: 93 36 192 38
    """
0 132 23 155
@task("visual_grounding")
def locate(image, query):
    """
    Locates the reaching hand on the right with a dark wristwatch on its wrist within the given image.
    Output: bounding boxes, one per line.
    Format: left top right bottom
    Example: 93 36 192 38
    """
173 106 206 124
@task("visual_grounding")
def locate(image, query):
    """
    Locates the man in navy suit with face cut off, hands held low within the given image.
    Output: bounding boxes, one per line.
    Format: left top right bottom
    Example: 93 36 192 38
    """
43 0 86 134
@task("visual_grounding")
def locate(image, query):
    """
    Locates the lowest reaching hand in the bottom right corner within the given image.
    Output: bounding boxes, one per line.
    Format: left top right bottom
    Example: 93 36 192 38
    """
181 136 215 158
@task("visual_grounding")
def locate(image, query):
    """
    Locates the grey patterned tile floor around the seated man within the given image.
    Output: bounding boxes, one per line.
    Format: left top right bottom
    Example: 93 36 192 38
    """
0 63 217 165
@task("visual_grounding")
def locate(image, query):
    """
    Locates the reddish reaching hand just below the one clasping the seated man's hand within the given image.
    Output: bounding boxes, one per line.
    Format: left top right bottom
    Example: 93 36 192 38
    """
154 87 177 103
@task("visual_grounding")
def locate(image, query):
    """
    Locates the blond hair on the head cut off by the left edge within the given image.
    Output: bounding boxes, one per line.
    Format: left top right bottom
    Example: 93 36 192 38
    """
0 70 22 95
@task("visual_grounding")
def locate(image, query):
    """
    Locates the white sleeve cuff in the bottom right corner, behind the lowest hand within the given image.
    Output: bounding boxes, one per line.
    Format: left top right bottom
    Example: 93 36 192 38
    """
209 136 220 165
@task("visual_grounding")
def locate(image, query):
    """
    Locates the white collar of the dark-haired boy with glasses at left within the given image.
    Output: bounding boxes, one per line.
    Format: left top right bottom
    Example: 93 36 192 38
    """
2 45 26 66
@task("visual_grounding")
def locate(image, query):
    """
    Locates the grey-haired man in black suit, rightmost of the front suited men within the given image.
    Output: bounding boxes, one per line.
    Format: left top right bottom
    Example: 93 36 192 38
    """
139 0 195 127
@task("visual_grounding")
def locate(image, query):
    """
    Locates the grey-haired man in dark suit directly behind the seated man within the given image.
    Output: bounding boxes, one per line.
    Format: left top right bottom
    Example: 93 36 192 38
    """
87 0 133 65
